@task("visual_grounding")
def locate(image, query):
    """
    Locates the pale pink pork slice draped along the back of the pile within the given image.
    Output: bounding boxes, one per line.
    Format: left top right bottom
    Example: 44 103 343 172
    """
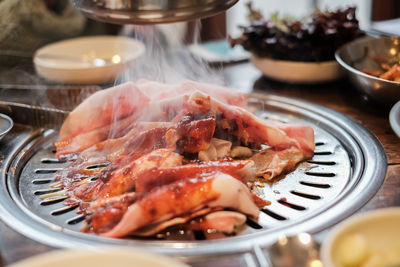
56 80 246 144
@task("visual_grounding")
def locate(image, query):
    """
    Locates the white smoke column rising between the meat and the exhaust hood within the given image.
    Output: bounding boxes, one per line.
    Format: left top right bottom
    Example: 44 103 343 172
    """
117 21 223 84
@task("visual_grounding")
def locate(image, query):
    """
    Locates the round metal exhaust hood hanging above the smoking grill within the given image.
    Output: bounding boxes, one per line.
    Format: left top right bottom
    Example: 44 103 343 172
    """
72 0 238 24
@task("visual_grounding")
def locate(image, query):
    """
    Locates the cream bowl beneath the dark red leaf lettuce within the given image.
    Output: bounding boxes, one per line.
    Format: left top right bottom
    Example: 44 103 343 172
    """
251 55 344 83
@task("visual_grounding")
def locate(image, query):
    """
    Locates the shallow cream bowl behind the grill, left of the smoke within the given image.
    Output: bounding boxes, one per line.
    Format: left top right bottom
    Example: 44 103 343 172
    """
33 36 145 84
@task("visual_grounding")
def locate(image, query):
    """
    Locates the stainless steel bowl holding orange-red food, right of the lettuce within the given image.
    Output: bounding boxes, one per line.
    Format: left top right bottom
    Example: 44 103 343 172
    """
335 37 400 105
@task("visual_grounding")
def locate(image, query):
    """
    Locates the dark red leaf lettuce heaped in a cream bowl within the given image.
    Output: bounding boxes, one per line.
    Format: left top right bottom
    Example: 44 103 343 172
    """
230 4 364 62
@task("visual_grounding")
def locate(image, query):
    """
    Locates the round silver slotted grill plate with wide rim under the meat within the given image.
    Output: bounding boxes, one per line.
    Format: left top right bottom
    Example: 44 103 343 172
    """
0 94 386 256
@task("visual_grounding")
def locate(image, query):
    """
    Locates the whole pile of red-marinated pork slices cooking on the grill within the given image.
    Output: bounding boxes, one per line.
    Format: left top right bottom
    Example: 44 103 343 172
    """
53 80 315 240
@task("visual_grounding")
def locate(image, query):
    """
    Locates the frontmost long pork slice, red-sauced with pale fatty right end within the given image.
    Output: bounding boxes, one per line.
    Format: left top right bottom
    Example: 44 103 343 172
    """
98 172 259 237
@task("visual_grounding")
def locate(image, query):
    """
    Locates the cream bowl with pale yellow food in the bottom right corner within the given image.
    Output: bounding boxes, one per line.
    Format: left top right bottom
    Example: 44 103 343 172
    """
321 207 400 267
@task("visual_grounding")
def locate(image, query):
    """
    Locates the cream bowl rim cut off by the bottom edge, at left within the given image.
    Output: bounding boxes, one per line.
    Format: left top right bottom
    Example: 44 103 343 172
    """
9 248 188 267
